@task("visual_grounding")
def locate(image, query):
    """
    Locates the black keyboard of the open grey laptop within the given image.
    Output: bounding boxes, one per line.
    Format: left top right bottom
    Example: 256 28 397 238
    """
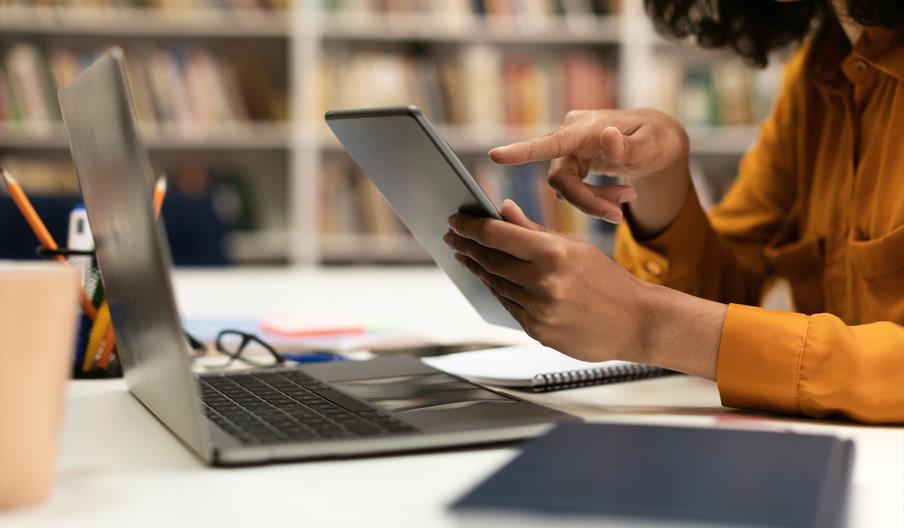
199 370 416 445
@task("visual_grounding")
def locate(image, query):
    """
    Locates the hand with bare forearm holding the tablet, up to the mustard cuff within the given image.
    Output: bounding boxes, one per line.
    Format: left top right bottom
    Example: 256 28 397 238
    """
443 200 725 378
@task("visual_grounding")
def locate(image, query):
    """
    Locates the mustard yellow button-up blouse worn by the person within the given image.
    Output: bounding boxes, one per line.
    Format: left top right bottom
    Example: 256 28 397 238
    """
616 24 904 422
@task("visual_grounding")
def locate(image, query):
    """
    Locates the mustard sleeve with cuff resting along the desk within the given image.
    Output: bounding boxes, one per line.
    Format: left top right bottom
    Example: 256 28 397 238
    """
716 304 904 423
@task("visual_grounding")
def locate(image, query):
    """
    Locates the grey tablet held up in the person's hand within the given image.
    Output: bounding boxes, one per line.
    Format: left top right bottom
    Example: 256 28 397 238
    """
326 106 521 329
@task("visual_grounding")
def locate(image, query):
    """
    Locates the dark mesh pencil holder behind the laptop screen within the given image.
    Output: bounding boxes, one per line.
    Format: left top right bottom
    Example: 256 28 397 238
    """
38 248 122 379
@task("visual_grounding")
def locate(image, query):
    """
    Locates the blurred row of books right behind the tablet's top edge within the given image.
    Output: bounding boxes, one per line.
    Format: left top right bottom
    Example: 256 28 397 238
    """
311 46 617 129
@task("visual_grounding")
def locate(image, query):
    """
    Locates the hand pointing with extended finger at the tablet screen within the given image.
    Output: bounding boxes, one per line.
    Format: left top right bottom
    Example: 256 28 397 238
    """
490 109 690 235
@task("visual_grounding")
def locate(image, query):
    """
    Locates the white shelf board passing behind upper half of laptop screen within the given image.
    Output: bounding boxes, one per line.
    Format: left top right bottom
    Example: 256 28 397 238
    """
0 122 290 151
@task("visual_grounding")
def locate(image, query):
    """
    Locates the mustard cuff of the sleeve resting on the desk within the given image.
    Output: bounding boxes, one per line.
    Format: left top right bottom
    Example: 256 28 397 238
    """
716 304 810 414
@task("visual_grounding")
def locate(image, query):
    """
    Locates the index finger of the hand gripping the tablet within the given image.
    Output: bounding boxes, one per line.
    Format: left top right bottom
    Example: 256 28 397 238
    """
449 213 548 261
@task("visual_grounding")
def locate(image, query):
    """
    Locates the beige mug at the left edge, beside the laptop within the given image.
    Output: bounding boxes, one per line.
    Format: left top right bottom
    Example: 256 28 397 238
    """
0 261 79 509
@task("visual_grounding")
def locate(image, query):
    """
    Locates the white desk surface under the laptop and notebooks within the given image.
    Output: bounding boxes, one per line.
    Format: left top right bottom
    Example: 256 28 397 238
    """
0 269 904 528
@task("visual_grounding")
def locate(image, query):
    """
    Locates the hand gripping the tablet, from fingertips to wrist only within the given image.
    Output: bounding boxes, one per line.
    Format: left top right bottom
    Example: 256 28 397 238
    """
443 200 645 361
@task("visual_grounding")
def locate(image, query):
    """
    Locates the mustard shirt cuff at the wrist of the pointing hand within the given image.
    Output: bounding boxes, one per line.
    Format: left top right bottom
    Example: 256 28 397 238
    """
615 187 709 284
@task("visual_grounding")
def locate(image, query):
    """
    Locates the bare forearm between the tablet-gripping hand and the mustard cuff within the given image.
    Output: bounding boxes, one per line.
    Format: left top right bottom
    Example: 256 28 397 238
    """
633 283 727 380
